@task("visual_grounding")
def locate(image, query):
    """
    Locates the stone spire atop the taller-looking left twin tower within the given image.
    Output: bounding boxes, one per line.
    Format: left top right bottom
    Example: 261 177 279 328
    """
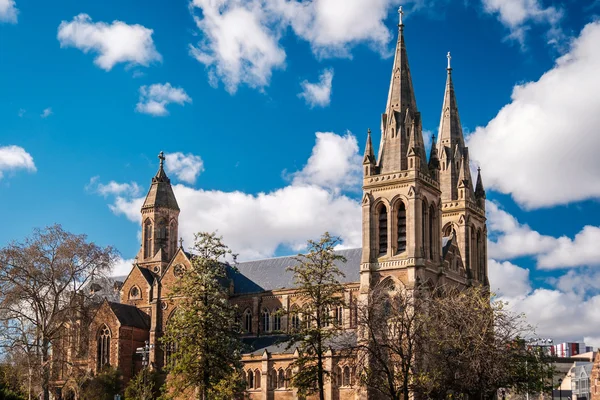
378 7 424 173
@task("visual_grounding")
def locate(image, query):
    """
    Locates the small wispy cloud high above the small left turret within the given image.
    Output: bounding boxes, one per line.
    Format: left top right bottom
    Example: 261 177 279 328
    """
135 82 192 117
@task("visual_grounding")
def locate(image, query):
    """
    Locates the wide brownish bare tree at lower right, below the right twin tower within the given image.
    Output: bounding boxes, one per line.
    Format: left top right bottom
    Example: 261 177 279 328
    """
422 286 552 398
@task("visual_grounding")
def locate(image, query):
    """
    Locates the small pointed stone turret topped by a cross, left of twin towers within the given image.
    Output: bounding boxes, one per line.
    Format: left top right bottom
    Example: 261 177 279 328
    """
137 151 179 275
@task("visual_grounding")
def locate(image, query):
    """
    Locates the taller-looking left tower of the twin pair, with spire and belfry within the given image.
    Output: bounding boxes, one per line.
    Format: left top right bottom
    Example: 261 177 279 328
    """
360 8 441 294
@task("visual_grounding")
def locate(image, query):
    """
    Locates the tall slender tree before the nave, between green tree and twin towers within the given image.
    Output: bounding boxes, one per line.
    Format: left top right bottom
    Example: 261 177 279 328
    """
288 232 346 400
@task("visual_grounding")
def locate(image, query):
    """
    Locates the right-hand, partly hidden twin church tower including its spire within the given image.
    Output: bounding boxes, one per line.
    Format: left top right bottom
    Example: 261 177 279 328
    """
432 53 488 284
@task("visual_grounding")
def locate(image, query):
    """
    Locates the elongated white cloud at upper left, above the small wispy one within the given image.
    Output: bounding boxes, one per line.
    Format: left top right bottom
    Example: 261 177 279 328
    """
58 14 162 71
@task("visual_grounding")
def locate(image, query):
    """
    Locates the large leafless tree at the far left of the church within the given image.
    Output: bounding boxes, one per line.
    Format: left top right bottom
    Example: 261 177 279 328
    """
0 225 116 400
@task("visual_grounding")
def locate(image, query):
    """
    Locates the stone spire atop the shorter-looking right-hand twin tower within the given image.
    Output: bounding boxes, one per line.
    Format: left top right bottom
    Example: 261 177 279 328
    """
437 53 468 201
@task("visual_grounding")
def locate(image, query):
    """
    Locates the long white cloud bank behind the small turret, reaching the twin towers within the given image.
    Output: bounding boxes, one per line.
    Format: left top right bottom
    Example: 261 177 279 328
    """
94 133 361 259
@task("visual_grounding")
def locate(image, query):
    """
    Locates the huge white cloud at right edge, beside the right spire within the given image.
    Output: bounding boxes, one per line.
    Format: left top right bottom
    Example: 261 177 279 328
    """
468 22 600 208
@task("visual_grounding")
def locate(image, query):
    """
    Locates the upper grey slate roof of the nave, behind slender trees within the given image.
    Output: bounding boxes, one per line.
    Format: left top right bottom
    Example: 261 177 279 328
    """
230 248 362 294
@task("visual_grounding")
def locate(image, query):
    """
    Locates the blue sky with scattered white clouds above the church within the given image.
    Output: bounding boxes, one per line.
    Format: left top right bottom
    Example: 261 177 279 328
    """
0 0 600 345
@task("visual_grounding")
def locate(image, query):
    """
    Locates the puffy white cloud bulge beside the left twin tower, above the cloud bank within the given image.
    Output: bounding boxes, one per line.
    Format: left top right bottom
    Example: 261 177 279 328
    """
292 132 362 190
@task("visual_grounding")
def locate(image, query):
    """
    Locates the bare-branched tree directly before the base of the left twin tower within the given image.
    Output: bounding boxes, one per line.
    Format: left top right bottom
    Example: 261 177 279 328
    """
356 280 429 400
